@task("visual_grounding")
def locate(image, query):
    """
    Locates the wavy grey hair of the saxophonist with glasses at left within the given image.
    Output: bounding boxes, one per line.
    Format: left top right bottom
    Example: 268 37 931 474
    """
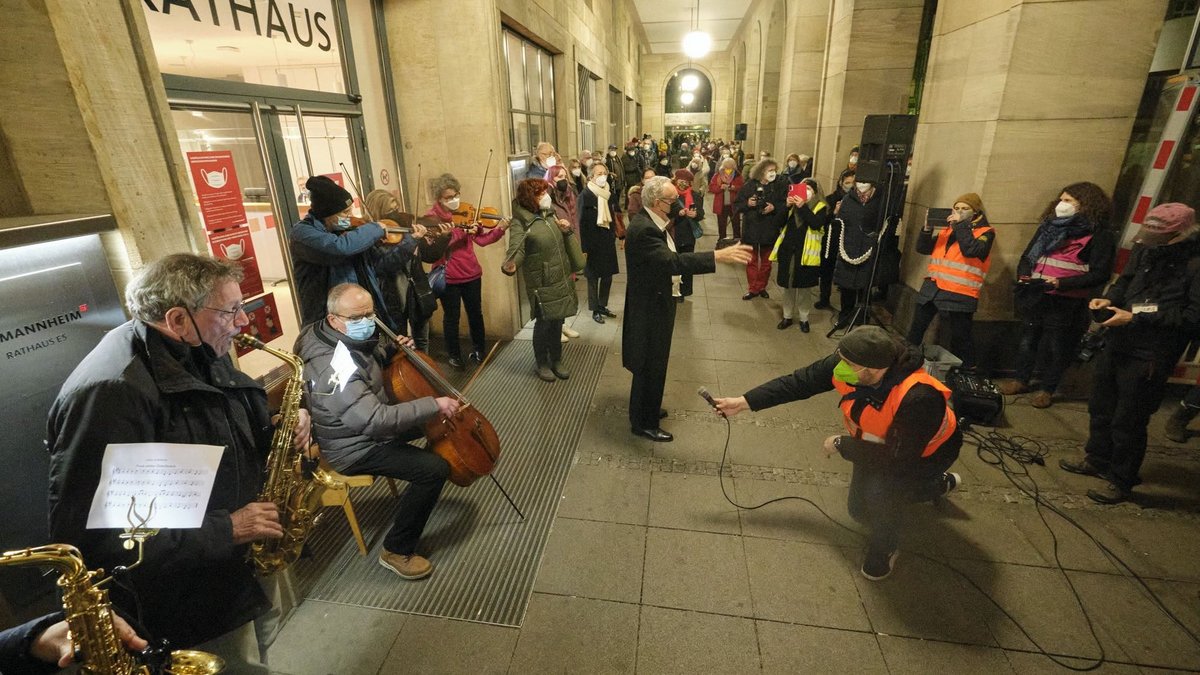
125 253 242 323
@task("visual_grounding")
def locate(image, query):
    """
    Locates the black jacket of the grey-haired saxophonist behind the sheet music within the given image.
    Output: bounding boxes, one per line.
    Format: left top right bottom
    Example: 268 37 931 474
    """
47 321 272 649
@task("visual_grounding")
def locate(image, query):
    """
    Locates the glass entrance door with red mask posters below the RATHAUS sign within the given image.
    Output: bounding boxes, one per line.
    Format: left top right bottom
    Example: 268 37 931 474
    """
172 101 361 380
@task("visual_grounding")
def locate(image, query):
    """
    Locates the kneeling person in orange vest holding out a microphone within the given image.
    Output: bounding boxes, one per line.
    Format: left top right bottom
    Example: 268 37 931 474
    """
713 325 962 581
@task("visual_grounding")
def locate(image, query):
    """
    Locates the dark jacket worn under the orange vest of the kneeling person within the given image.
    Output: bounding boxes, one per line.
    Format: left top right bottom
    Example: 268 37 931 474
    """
745 344 962 467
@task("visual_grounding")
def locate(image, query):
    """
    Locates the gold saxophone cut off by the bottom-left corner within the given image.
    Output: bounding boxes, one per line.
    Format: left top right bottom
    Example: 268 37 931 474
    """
0 544 224 675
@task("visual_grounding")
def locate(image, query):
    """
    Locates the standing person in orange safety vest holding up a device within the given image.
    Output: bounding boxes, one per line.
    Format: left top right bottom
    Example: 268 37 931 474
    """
908 192 996 368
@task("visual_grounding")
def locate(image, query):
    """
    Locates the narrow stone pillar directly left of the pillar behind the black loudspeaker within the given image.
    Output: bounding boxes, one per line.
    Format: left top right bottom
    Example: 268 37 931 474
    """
774 0 832 159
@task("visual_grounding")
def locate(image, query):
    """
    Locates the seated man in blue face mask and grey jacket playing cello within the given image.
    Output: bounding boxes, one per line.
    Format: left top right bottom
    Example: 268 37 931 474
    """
295 283 458 579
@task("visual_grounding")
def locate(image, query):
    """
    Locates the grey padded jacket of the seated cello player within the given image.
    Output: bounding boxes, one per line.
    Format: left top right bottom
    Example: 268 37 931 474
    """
295 321 438 471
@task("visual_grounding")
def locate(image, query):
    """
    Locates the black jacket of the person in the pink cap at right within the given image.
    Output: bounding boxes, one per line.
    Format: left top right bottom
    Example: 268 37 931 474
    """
1104 234 1200 365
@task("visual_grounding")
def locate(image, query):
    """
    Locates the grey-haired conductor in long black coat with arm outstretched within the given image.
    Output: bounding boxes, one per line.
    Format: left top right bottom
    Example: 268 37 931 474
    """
620 177 750 442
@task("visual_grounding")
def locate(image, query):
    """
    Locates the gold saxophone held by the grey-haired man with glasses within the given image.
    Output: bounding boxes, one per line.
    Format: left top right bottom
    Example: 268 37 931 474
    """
234 334 334 575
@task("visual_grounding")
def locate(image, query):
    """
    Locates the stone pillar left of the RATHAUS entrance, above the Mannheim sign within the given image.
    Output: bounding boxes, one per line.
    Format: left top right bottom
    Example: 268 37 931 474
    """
0 0 206 281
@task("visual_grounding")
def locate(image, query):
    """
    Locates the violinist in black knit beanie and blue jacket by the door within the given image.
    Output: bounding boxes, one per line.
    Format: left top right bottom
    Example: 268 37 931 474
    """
288 175 417 330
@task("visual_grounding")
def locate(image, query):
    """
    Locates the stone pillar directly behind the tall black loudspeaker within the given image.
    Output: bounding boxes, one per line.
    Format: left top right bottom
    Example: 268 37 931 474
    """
814 0 925 187
